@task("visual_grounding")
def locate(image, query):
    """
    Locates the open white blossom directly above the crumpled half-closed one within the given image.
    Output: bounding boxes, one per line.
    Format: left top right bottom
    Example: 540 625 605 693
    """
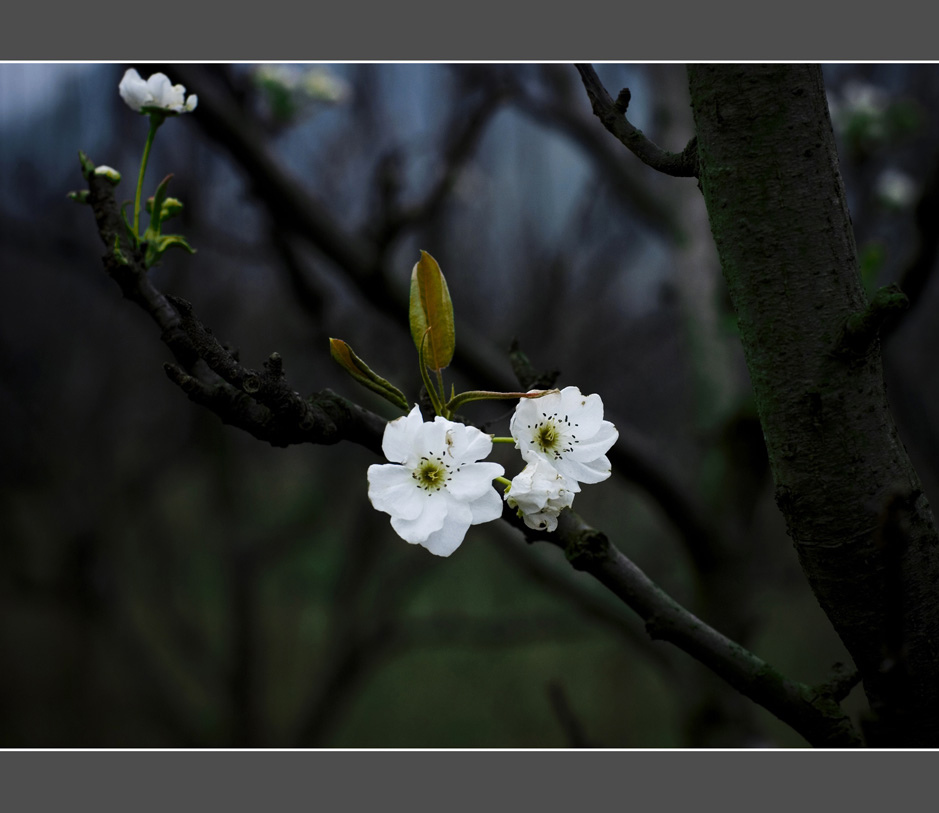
509 387 619 483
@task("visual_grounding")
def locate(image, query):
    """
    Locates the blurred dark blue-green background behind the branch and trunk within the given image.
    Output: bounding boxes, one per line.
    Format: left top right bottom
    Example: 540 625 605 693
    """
0 64 939 748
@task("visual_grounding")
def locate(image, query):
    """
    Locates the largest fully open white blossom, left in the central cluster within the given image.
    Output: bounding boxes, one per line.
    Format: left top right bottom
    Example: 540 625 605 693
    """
368 406 505 556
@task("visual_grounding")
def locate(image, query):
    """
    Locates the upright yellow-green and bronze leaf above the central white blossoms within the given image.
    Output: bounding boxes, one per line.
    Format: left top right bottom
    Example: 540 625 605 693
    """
410 251 456 372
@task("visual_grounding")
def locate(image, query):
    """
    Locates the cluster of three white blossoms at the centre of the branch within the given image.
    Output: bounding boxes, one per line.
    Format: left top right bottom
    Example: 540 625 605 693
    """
368 387 618 556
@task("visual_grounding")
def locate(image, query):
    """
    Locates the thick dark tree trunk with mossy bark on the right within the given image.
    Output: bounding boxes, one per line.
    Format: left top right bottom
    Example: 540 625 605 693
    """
689 65 939 747
